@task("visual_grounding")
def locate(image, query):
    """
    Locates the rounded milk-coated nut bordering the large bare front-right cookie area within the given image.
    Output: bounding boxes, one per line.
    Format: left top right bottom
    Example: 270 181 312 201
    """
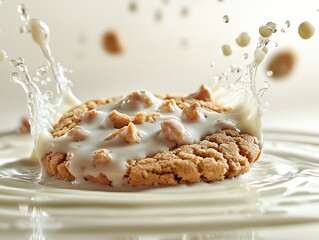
159 119 193 145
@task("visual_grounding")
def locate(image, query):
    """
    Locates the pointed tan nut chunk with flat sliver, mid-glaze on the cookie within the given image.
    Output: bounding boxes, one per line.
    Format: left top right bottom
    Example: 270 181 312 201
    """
104 123 142 143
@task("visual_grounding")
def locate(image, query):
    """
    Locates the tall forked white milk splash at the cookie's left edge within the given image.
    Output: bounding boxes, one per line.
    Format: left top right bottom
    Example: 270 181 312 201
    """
10 4 81 156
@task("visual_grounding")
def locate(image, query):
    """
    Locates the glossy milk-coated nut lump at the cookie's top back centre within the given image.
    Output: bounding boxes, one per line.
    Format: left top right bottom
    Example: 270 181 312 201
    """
117 91 156 110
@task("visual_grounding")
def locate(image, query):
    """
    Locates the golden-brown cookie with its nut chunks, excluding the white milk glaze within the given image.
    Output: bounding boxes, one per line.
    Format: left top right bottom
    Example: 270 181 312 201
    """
42 87 261 186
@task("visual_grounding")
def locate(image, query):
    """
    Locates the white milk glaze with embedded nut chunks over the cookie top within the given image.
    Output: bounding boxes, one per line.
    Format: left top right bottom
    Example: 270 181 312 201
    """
39 87 262 186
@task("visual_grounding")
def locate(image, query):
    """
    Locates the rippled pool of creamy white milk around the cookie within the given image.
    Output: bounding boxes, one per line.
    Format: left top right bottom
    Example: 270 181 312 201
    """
0 131 319 240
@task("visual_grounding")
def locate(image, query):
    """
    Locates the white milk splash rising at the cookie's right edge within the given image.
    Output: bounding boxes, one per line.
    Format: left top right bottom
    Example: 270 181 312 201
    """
212 37 270 140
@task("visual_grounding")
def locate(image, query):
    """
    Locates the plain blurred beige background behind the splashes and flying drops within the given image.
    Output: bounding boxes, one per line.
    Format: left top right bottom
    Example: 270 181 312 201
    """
0 0 319 132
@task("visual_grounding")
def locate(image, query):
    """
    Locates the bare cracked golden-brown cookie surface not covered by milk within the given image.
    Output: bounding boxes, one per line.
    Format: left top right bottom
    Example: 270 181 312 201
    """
42 95 261 186
